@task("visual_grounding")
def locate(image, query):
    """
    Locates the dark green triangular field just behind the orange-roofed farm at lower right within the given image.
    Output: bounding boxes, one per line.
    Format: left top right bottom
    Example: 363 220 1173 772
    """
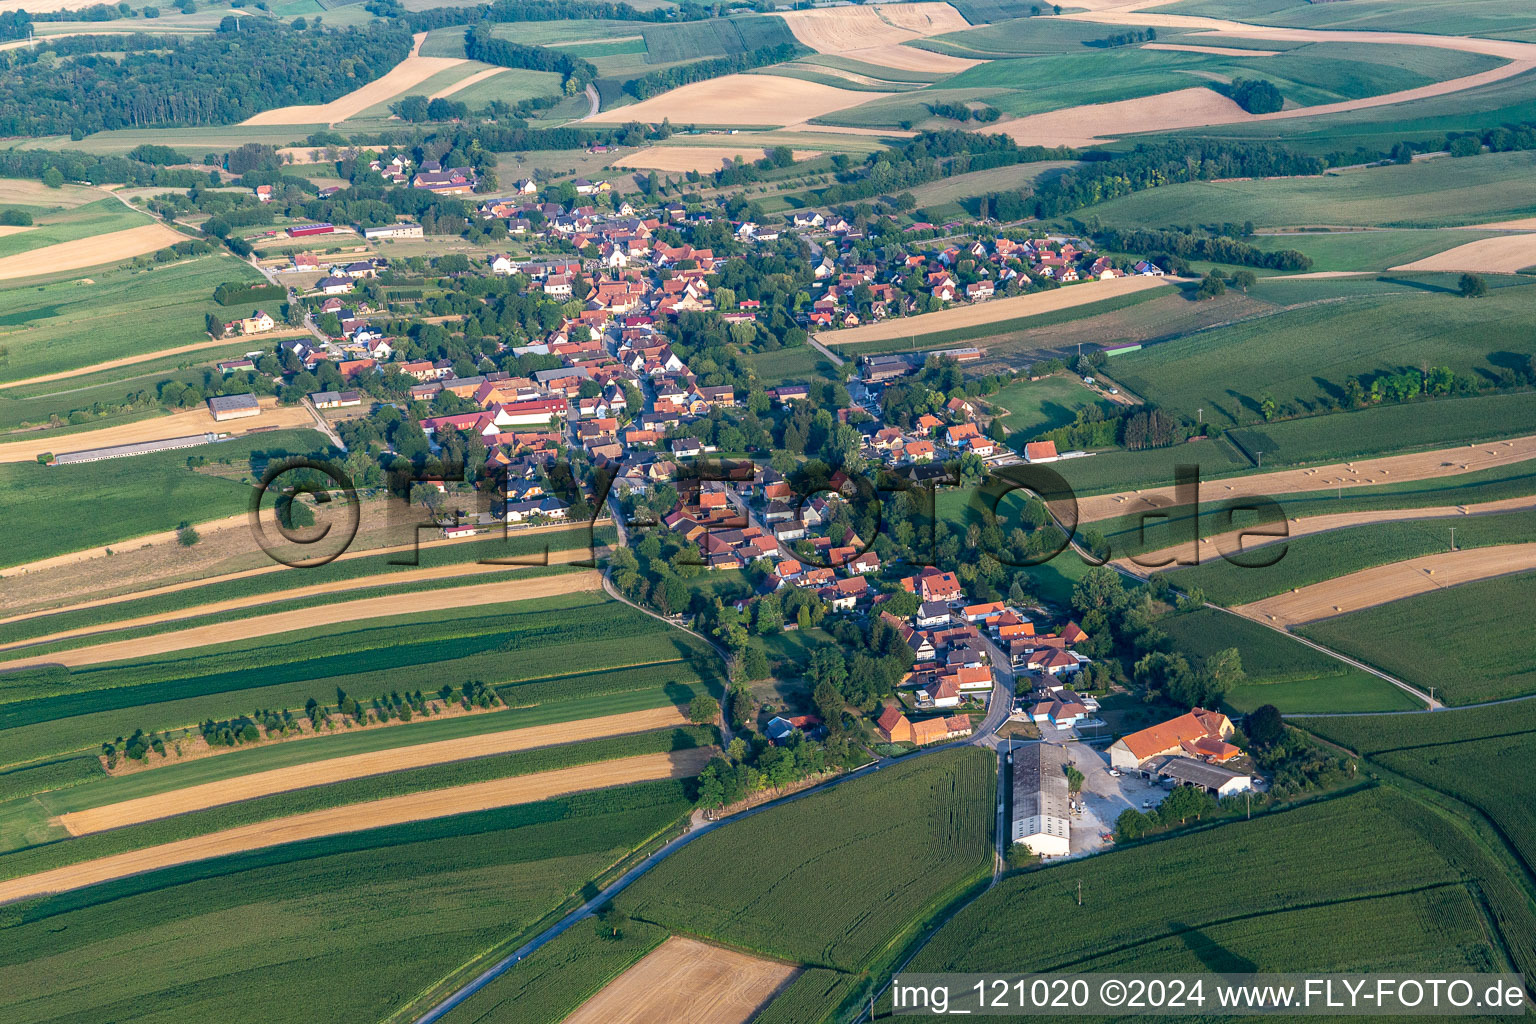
1158 608 1421 714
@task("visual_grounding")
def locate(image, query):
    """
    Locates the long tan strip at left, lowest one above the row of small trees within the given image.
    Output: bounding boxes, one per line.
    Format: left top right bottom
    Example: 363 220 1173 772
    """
5 570 602 668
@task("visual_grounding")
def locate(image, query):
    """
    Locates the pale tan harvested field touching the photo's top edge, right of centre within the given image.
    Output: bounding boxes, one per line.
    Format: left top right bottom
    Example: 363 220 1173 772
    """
779 3 980 72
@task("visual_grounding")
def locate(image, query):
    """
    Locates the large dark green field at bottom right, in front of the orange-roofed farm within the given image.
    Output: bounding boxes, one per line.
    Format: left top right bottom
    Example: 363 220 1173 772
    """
906 789 1533 1009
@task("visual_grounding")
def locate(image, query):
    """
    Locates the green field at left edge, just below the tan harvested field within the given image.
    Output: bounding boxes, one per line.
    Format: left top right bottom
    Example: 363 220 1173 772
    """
0 254 265 386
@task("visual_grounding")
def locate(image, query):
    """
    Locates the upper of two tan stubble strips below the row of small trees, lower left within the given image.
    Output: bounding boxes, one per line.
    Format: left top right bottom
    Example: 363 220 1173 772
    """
58 705 688 835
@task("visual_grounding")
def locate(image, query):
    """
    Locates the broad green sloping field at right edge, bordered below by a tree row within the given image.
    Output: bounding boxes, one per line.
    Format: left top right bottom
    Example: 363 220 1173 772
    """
1112 286 1536 427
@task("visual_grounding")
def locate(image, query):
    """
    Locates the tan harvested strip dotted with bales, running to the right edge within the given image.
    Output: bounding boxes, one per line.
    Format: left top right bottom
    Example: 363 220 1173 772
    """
1077 438 1536 522
